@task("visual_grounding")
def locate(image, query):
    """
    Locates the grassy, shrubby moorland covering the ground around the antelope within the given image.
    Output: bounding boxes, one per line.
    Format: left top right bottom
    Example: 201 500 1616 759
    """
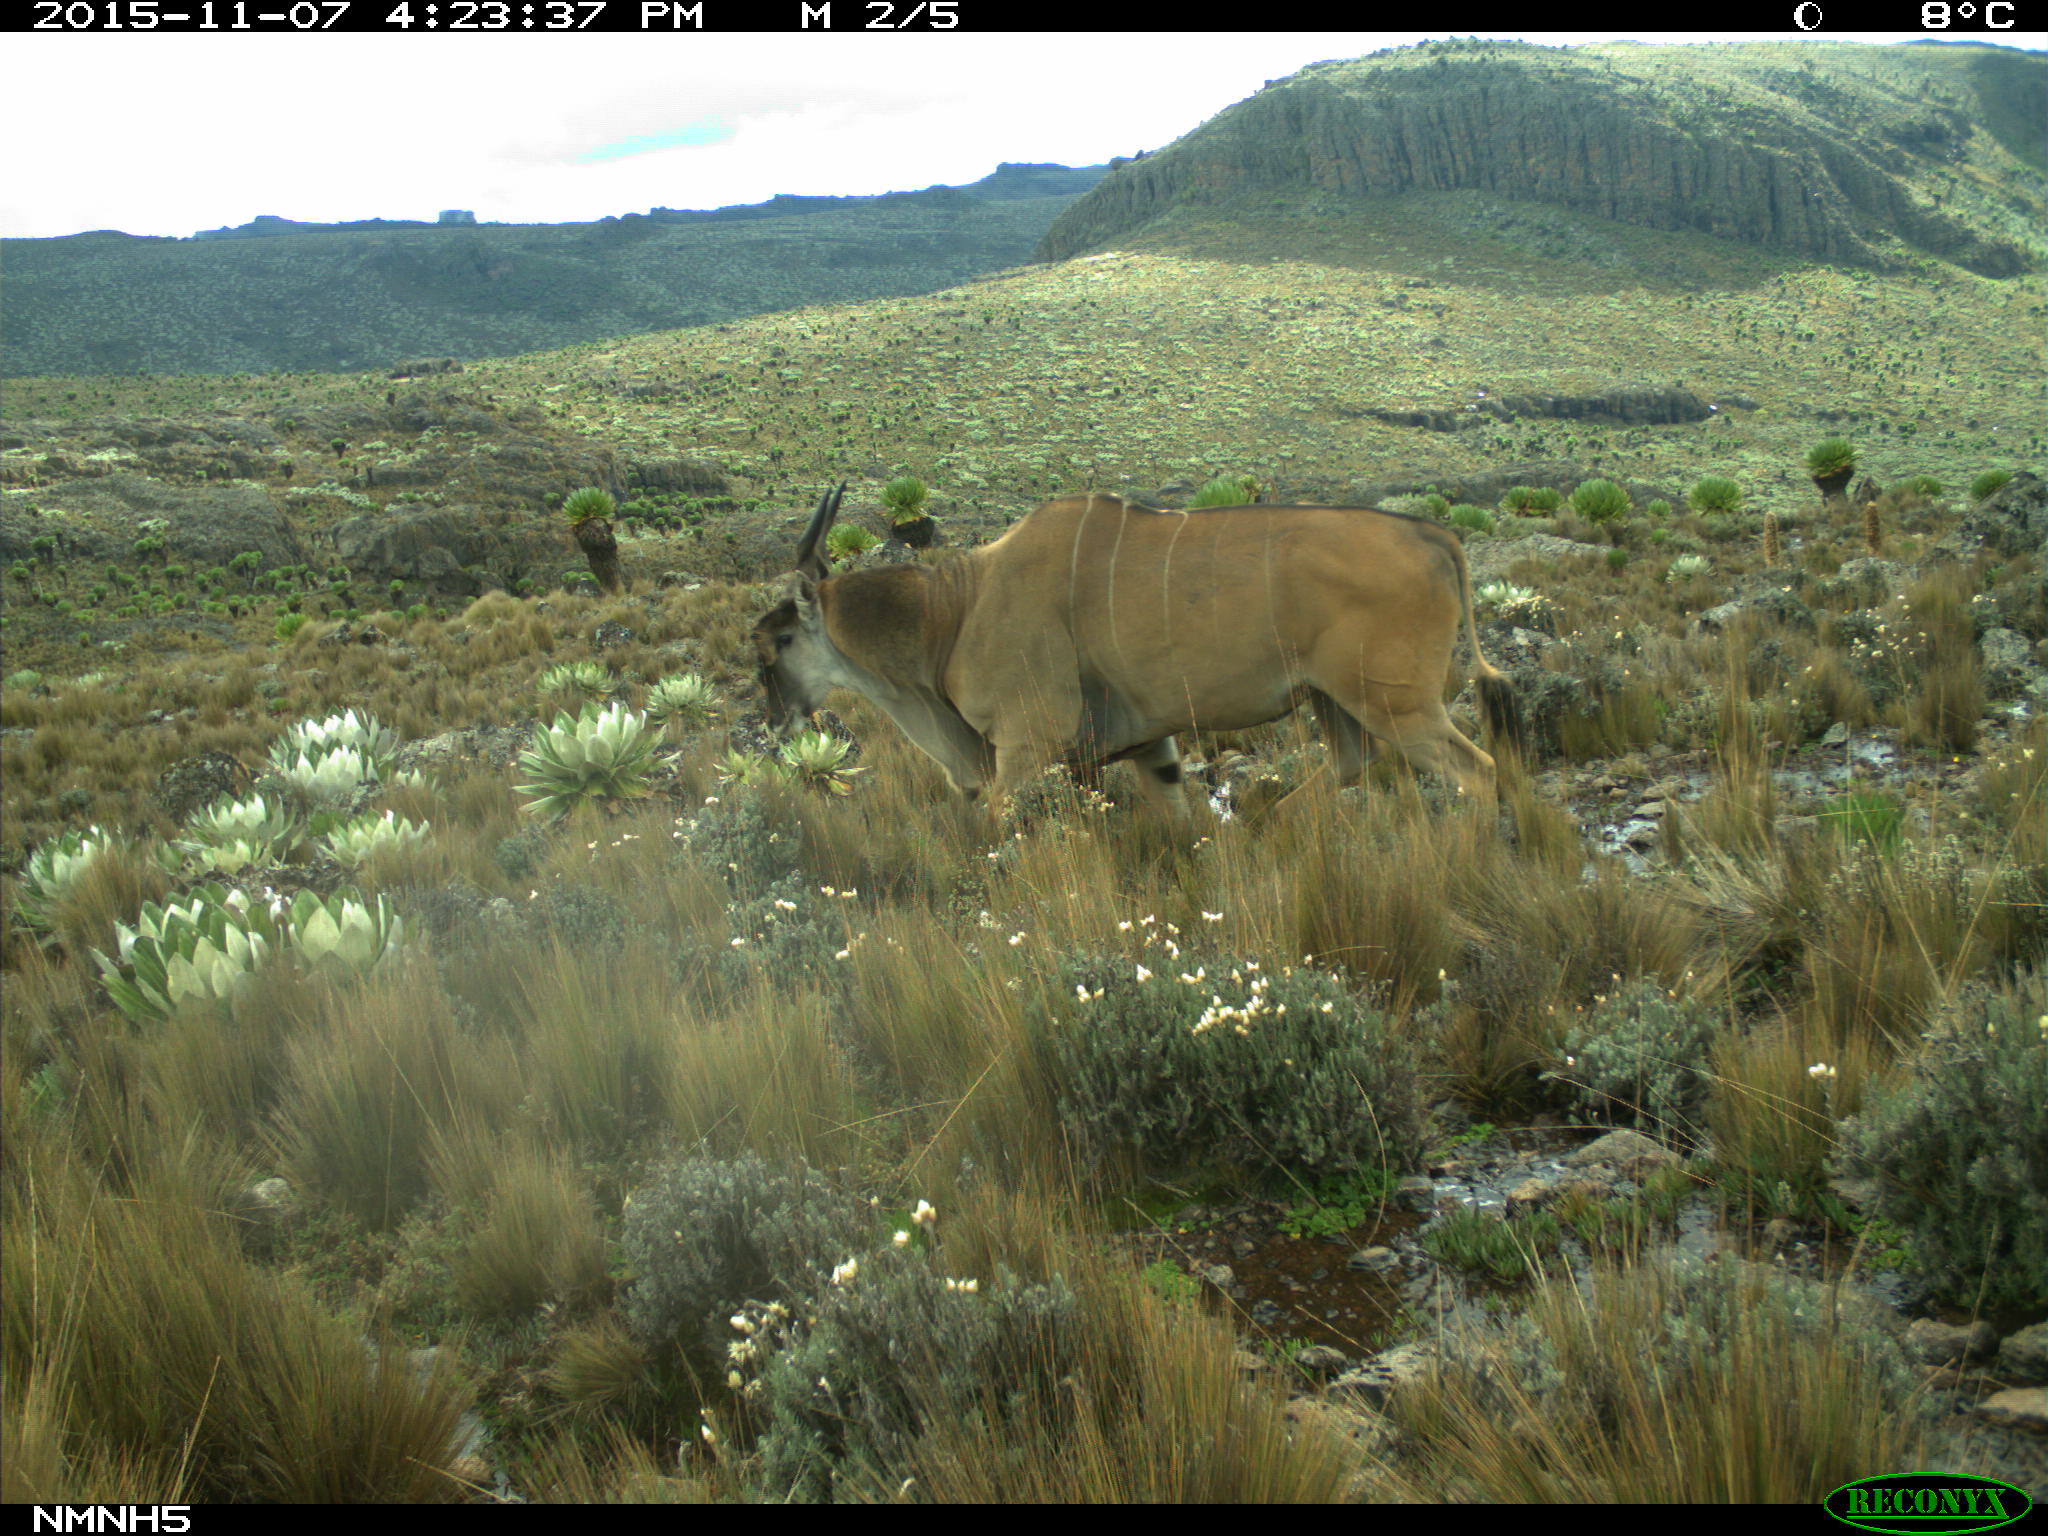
0 45 2048 1503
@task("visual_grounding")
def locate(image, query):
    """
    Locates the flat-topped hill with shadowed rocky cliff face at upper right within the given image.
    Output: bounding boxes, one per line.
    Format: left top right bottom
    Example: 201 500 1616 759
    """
1038 41 2048 276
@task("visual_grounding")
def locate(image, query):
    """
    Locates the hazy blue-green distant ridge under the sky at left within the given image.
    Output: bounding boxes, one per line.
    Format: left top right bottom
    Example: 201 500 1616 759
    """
0 164 1106 377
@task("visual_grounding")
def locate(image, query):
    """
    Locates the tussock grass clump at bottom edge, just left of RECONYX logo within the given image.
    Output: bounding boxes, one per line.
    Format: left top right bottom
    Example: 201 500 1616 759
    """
1380 1260 1927 1503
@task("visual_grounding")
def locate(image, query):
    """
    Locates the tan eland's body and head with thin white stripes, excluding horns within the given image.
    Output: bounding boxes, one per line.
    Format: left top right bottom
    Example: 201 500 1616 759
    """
756 496 1513 811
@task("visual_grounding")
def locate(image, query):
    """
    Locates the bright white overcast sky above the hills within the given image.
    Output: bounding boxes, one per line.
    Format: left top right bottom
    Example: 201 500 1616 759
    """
0 31 2044 238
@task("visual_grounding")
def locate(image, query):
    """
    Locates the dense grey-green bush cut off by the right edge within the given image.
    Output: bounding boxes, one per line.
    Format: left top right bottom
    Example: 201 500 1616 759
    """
1839 973 2048 1311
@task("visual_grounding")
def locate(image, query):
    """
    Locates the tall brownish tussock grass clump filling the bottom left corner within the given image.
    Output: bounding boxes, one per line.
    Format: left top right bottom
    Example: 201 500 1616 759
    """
0 1163 467 1503
